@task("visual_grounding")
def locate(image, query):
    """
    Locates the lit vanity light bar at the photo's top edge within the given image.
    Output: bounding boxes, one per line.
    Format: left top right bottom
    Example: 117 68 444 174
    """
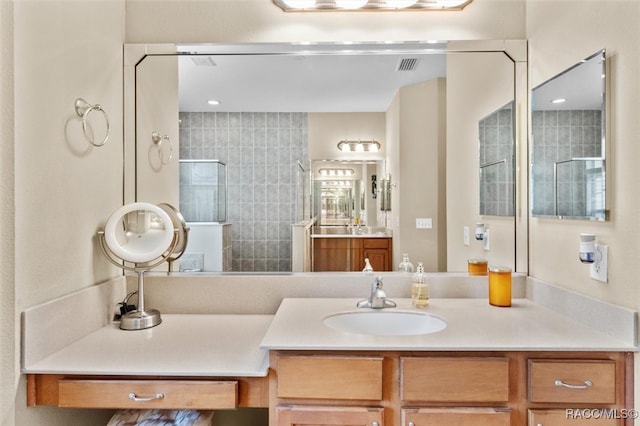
273 0 473 12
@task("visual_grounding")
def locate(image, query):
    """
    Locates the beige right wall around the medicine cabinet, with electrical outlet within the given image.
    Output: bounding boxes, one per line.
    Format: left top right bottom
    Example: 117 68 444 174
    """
527 0 640 309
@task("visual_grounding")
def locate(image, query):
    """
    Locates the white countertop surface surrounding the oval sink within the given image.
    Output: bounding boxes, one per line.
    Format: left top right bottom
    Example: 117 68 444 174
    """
261 298 637 351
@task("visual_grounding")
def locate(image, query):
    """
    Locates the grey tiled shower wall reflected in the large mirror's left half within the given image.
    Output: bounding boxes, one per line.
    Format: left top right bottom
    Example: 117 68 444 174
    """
180 112 309 272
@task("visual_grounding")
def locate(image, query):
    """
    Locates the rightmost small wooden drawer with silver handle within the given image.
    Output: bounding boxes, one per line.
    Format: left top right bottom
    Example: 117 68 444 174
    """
529 360 616 404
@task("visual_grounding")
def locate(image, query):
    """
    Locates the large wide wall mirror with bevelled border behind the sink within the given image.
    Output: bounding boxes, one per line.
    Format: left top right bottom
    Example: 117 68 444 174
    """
125 41 526 273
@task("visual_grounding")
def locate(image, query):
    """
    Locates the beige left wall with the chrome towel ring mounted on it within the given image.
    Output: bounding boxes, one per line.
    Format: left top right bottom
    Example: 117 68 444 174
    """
5 0 125 425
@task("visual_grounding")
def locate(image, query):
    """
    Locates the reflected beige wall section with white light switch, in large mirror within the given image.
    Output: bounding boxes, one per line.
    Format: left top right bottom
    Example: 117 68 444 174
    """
387 79 447 271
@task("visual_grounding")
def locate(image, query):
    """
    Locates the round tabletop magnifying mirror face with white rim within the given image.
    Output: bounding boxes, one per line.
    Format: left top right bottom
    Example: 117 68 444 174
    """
104 203 174 263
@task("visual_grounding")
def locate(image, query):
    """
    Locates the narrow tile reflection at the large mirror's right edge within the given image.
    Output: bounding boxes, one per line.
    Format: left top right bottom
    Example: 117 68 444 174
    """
478 104 514 216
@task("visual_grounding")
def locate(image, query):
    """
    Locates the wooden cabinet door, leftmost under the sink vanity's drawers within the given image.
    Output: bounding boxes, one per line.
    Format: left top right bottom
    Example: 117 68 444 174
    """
276 406 384 426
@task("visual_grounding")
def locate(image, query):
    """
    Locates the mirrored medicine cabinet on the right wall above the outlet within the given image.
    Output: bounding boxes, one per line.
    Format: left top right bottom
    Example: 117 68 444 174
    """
531 50 607 221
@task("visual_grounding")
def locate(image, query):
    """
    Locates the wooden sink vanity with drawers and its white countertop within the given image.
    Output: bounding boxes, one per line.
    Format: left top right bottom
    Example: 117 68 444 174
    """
263 299 633 426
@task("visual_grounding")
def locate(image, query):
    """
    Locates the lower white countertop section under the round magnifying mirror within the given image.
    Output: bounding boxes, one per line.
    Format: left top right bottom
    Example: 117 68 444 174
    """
23 314 273 377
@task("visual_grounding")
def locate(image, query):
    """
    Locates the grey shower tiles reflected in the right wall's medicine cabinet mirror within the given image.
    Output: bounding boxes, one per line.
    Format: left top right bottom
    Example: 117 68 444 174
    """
532 110 604 216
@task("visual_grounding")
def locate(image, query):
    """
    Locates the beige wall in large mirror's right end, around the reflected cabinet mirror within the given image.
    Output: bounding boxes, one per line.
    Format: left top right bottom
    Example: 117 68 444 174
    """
447 52 515 271
